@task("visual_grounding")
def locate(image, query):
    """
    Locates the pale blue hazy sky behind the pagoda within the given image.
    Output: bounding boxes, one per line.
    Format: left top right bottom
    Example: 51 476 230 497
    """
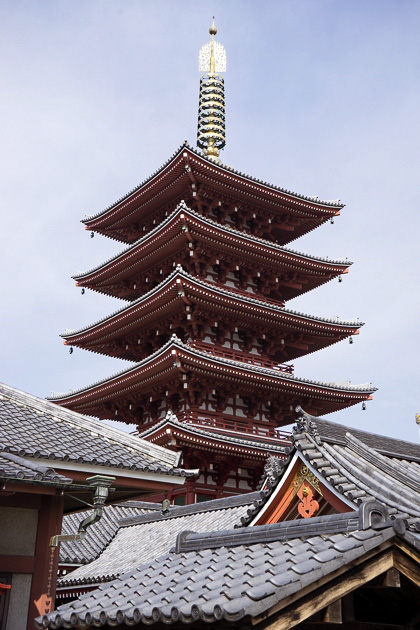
0 0 420 440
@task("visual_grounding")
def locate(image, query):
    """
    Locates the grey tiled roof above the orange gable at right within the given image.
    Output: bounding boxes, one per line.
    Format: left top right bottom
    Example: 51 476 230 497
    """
242 410 420 527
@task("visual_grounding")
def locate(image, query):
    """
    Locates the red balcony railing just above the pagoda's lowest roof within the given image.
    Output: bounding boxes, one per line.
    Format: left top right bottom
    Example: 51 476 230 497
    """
177 411 291 446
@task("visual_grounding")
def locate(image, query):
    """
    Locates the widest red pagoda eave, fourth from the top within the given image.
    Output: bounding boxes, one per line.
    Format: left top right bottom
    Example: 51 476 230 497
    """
50 339 374 424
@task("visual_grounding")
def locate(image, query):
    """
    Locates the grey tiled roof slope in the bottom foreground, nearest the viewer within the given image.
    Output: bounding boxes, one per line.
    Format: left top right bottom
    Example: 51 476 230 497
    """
36 517 396 628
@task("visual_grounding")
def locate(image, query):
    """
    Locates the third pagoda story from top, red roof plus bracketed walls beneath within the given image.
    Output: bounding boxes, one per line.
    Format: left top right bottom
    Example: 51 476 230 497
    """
62 265 362 367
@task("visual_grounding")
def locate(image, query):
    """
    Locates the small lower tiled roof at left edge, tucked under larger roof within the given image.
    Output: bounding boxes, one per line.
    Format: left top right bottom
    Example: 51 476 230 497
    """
0 452 72 486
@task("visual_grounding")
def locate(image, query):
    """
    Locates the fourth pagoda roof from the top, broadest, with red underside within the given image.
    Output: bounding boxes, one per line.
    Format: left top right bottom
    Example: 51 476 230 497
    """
49 335 375 420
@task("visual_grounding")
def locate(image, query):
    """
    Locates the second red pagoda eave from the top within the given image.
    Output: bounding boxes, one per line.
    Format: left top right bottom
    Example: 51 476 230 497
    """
73 204 351 300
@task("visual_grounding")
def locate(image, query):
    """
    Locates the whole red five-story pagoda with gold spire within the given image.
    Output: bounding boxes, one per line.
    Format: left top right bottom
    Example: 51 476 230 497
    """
51 22 373 503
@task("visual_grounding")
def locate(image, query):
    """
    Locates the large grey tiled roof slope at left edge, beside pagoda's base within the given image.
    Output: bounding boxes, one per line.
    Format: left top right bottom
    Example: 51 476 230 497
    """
0 384 184 476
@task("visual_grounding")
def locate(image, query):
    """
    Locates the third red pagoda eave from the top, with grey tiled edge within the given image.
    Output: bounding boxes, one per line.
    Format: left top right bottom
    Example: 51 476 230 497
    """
62 269 361 360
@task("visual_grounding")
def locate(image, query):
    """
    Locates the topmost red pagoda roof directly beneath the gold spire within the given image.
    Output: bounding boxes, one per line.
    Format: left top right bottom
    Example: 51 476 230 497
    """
83 143 344 243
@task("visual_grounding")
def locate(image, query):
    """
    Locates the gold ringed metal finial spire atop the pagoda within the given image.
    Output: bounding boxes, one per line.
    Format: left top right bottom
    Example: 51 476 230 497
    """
197 17 226 159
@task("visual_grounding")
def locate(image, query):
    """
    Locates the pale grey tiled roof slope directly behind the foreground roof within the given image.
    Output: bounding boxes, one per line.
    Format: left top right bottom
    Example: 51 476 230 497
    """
58 492 260 588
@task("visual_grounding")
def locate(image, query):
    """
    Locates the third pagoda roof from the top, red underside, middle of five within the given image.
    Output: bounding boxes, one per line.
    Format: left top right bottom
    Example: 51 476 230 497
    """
61 265 363 360
